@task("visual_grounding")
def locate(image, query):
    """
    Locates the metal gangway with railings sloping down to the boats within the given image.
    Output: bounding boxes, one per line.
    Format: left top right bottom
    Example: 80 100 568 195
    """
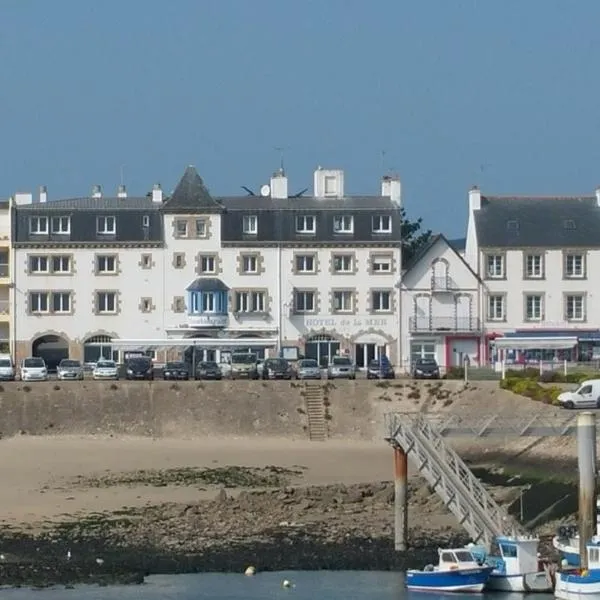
385 412 577 547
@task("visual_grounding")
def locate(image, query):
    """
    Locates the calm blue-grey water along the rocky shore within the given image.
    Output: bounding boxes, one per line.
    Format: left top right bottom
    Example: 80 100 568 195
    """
0 571 552 600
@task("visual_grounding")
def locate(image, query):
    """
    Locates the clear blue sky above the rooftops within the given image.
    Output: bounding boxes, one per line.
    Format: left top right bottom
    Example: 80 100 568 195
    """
0 0 600 236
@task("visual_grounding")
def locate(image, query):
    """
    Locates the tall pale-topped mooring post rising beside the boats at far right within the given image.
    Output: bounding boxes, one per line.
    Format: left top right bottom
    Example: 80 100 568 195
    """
577 412 596 569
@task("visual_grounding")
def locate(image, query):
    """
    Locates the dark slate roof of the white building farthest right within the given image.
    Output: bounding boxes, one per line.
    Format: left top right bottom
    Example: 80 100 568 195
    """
475 196 600 248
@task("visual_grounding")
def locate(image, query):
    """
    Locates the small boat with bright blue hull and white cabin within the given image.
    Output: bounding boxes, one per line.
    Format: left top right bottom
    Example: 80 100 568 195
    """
406 548 494 593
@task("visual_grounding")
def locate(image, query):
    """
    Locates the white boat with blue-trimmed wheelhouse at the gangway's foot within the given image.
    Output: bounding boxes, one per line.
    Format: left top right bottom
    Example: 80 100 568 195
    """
468 536 554 593
